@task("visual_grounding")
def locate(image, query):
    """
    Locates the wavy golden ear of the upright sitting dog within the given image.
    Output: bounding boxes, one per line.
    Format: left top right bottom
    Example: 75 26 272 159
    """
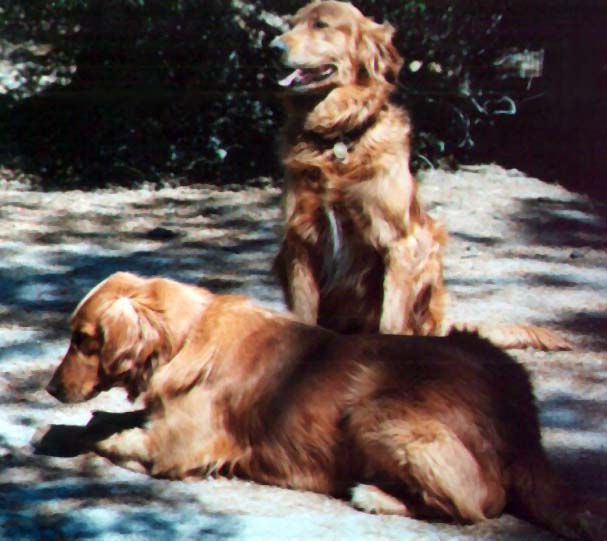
358 19 403 84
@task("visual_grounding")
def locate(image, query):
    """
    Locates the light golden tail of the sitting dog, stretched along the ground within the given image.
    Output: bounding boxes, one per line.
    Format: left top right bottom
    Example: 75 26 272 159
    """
452 323 573 351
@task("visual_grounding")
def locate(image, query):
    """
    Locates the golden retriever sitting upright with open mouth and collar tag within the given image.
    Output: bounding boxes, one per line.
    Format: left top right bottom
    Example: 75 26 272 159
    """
271 1 571 350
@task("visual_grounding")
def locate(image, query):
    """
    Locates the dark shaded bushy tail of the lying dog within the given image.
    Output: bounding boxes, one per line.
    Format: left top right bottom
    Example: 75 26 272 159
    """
510 455 607 541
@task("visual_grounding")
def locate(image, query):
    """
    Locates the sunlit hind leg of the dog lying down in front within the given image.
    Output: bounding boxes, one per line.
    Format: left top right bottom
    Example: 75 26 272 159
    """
354 416 506 522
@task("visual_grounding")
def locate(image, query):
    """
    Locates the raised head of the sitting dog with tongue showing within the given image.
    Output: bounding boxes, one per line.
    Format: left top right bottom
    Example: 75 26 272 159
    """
271 1 402 93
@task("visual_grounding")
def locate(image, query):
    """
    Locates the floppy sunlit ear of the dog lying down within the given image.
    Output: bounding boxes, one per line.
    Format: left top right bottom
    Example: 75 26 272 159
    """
99 296 171 399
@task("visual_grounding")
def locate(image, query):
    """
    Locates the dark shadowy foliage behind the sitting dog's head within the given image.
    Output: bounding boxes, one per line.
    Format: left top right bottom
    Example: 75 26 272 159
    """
0 0 607 194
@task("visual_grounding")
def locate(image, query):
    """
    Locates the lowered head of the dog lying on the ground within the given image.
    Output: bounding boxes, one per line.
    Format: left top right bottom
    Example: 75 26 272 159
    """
47 273 202 402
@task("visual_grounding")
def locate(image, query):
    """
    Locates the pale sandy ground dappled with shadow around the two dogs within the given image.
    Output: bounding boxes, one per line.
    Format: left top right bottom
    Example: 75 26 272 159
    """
0 166 607 541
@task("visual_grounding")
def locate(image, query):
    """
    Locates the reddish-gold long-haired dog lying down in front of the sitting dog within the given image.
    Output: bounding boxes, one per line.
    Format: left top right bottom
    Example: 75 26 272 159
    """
48 273 605 540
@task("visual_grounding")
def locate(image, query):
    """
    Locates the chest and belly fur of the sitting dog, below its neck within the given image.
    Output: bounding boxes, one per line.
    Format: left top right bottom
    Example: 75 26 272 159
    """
282 97 414 332
